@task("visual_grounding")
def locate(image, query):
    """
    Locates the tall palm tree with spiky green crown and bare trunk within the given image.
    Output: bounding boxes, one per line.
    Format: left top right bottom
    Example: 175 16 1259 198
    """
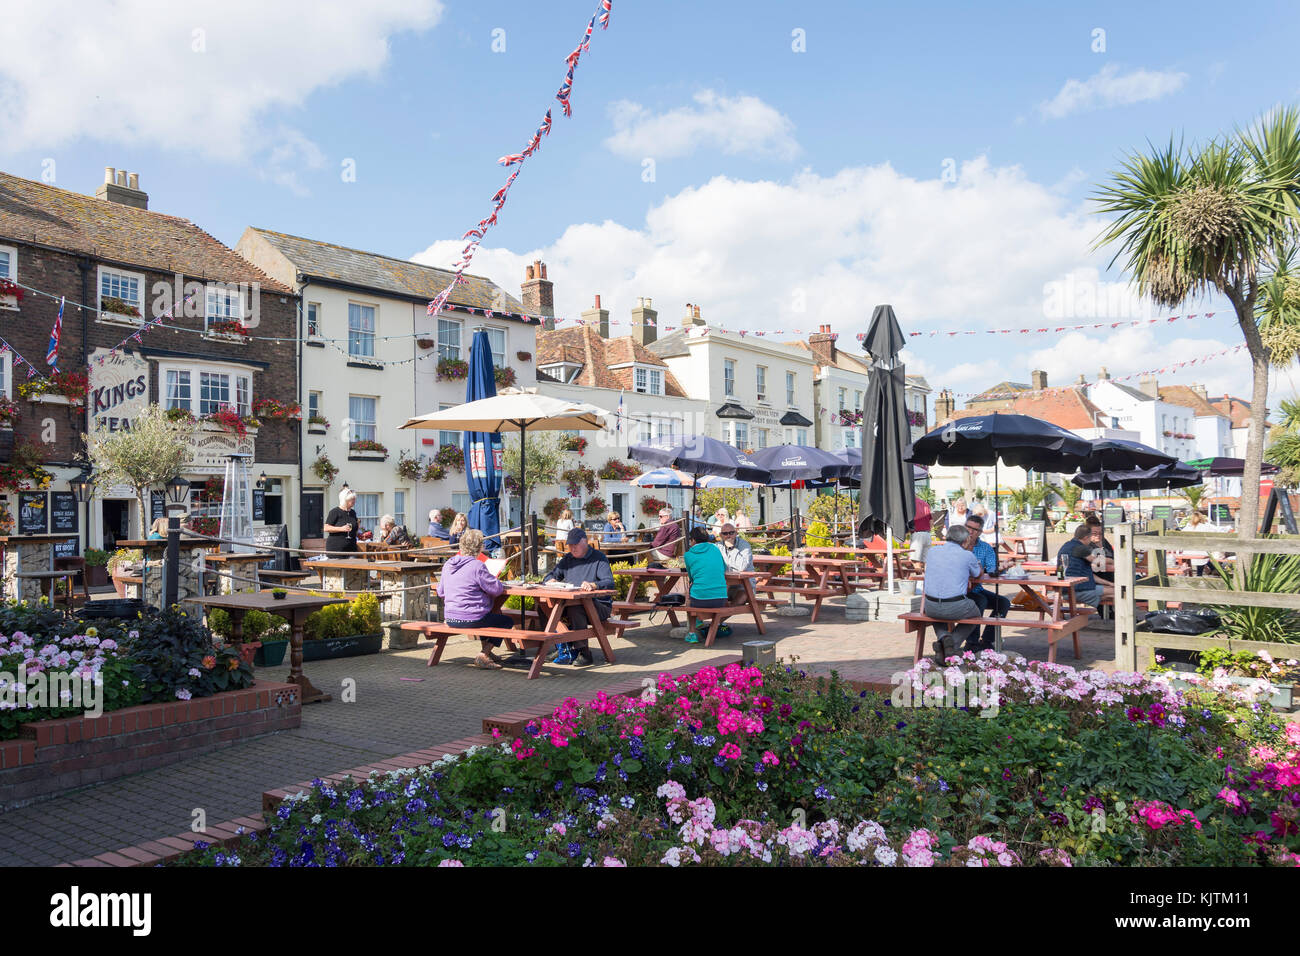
1095 107 1300 537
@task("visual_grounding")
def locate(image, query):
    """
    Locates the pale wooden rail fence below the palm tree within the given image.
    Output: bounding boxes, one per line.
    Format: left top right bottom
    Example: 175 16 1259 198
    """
1115 522 1300 671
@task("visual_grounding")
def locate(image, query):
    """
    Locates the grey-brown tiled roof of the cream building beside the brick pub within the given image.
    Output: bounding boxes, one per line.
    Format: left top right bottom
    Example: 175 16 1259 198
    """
241 226 527 313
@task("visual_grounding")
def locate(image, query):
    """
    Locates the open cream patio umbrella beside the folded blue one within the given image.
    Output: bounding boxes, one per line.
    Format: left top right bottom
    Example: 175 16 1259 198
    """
402 389 610 574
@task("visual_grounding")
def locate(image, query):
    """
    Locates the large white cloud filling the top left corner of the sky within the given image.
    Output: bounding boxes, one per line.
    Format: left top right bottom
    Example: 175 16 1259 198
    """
0 0 442 185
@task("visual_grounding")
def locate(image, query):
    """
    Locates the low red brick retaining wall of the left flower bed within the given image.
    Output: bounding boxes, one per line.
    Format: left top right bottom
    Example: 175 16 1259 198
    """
0 680 303 810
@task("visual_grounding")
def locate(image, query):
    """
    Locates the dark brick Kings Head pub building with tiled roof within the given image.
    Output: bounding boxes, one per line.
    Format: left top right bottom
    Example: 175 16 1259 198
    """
0 169 300 548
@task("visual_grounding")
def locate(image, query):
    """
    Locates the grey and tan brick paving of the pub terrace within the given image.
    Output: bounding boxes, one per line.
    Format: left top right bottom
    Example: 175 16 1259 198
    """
0 601 1114 866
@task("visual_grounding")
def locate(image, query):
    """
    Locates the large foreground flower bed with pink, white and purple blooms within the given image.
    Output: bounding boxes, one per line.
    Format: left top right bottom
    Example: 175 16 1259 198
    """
182 652 1300 866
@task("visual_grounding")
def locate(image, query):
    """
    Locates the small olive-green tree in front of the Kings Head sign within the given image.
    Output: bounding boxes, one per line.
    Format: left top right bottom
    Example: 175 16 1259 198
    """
82 405 194 535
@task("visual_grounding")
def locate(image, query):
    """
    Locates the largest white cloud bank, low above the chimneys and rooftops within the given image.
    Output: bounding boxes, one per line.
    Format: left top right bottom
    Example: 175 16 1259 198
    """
415 157 1249 394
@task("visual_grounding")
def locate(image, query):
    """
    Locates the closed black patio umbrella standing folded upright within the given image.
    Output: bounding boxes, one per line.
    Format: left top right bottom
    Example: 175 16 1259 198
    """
858 306 917 593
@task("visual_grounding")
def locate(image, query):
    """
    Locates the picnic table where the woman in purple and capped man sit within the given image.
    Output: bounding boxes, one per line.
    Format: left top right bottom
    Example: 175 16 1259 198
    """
402 585 631 680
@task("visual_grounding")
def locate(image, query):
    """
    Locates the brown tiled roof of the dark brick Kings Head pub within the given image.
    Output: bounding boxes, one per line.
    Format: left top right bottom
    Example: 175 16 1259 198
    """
0 173 293 294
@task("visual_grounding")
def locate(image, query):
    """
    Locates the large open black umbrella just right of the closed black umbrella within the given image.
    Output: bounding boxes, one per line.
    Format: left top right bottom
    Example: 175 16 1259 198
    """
907 412 1092 564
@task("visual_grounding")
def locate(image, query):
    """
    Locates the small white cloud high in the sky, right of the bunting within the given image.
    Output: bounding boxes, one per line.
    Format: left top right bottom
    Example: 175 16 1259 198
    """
605 90 800 160
